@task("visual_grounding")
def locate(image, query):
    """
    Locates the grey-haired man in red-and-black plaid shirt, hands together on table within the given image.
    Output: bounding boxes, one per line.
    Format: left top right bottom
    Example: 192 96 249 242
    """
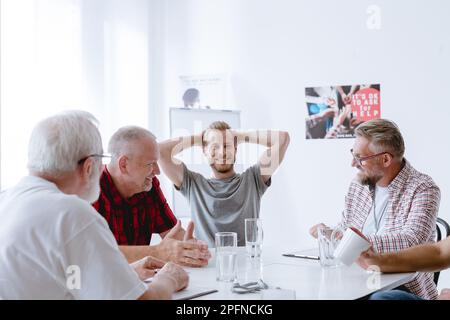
93 126 211 267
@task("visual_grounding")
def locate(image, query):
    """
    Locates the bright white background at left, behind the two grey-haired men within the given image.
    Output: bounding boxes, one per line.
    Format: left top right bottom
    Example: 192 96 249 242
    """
0 0 153 189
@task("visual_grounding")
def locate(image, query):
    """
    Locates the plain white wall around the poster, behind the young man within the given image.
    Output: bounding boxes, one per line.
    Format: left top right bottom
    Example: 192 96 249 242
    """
160 0 450 288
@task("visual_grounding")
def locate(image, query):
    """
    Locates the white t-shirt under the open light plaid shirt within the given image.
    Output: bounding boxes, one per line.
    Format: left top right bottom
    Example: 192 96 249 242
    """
363 186 389 236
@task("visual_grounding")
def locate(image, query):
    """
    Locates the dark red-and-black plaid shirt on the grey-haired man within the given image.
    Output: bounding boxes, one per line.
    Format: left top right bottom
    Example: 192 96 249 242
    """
93 166 177 245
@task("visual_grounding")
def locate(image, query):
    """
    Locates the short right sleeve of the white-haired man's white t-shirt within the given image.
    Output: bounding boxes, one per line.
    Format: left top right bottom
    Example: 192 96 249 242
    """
63 217 147 300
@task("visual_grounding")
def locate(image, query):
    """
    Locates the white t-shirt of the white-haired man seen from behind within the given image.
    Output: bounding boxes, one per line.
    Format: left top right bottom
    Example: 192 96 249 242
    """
0 176 147 299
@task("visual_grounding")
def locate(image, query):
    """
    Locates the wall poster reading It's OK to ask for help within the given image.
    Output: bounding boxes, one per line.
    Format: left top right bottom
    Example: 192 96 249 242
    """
305 84 381 139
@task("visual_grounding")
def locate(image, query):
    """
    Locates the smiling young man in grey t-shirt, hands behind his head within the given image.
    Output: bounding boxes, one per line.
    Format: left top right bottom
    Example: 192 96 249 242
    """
159 121 289 247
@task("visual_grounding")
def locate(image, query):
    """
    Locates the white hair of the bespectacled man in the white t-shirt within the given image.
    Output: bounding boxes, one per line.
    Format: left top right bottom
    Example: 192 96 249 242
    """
27 110 102 177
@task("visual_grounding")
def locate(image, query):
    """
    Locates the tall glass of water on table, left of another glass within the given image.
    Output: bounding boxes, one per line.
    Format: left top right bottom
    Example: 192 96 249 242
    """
215 232 237 282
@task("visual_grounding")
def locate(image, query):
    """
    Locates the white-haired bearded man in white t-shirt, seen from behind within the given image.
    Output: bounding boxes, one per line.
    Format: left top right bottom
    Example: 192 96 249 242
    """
0 111 188 299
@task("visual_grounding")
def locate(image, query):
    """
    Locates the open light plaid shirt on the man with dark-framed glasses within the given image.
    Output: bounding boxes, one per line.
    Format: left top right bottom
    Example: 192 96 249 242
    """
342 160 440 299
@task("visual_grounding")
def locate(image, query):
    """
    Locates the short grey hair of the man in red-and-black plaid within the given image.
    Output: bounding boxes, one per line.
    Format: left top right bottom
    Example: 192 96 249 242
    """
108 126 156 160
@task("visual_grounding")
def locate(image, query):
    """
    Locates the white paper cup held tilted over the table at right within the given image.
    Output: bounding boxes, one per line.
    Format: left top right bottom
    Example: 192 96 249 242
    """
334 228 370 266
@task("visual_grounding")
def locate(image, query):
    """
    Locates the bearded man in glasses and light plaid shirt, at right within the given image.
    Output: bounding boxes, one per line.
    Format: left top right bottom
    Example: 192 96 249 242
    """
310 119 440 299
